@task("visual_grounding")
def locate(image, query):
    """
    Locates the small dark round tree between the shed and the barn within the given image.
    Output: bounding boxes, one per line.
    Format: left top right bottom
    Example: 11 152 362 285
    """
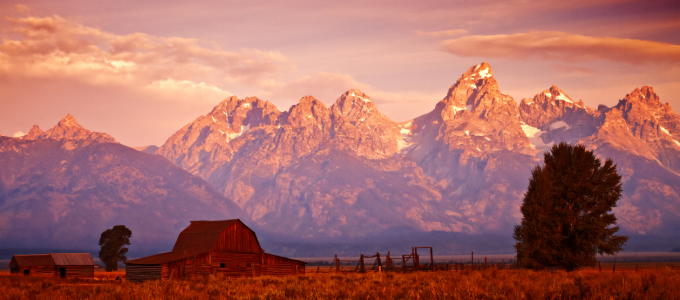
99 225 132 272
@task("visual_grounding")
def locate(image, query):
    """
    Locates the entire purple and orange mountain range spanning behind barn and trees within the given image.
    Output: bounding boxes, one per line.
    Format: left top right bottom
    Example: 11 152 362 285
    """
0 63 680 253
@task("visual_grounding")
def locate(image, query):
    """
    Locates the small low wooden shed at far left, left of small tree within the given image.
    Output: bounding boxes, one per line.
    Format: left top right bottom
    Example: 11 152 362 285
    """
9 253 95 278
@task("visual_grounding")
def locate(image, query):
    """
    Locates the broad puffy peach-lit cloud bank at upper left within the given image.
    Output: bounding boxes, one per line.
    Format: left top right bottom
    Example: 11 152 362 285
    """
0 16 294 101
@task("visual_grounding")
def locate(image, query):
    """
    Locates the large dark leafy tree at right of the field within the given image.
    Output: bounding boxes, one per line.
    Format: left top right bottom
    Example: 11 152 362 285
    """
513 143 628 271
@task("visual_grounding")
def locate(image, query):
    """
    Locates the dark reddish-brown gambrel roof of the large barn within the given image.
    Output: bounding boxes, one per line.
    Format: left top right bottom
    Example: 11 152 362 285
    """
172 219 261 254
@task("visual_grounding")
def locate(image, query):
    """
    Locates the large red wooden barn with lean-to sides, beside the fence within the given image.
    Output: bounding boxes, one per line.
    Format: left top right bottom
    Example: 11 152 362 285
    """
125 219 307 282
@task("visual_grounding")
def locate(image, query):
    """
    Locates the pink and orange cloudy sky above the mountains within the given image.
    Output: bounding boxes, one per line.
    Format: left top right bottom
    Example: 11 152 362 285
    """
0 0 680 146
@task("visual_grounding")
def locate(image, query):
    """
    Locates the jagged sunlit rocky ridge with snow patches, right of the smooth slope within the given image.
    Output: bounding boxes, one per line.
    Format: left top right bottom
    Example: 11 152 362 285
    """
156 63 680 237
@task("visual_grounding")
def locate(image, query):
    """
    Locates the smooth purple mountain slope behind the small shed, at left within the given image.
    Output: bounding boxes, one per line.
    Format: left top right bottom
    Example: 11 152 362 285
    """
0 117 246 249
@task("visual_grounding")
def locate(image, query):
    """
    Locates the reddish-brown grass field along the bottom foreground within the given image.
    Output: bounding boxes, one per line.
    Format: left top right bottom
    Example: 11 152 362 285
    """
0 267 680 299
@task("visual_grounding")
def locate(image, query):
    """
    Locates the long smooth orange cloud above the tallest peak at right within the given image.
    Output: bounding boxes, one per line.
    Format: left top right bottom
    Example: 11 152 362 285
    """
442 31 680 65
